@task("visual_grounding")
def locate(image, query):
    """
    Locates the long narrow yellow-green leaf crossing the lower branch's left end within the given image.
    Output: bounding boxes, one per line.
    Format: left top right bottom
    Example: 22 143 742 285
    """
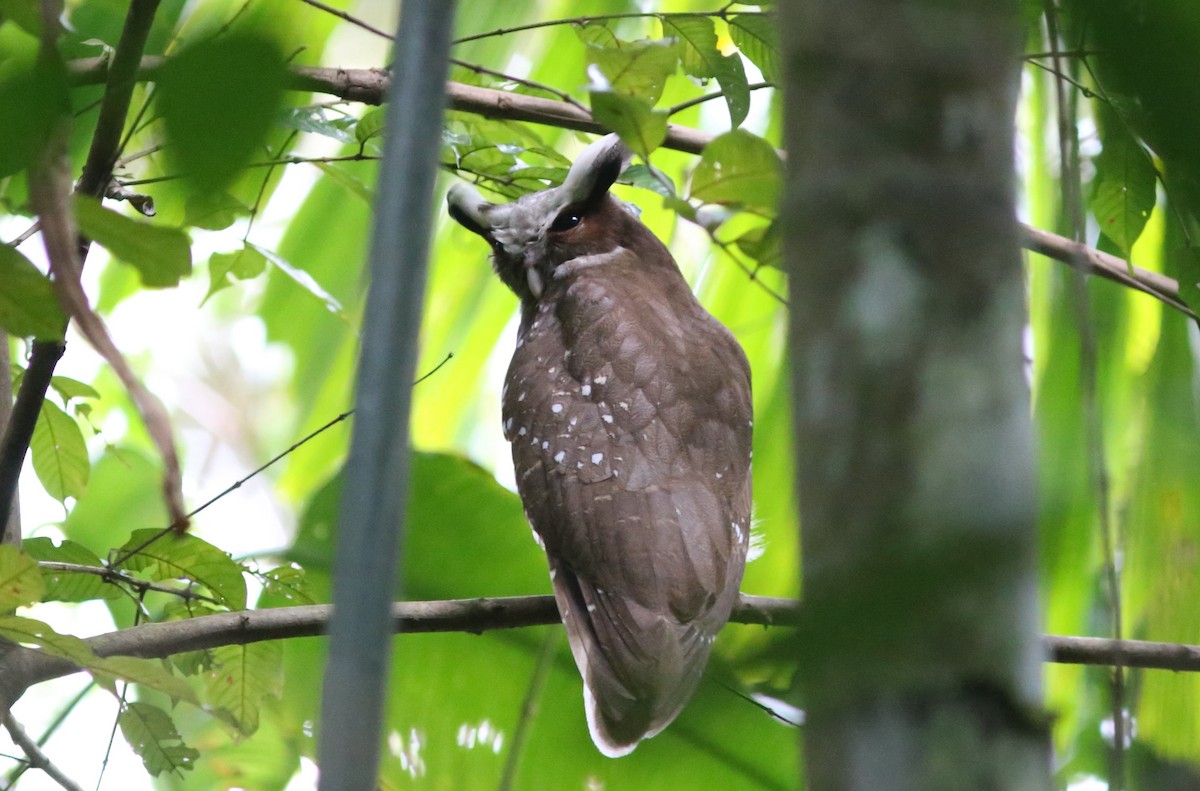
0 616 197 703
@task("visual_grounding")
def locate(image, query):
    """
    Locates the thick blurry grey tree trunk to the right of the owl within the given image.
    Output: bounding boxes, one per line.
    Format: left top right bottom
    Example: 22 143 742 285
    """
781 0 1050 791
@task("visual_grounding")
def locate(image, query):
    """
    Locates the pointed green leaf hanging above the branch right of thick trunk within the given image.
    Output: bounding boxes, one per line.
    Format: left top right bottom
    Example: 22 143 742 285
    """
1087 130 1156 258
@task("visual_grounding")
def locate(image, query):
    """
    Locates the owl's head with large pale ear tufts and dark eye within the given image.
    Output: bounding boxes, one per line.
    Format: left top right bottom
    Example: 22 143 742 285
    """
446 134 641 304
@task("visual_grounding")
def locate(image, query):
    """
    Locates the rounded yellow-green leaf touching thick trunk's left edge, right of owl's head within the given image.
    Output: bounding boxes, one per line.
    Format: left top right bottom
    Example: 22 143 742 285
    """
690 130 784 215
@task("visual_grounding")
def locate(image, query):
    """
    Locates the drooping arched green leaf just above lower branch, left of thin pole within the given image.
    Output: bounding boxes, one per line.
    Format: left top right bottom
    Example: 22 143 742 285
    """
113 528 246 610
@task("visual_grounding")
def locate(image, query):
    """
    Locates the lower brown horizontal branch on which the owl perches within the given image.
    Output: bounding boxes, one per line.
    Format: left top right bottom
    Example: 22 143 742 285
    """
0 594 1200 708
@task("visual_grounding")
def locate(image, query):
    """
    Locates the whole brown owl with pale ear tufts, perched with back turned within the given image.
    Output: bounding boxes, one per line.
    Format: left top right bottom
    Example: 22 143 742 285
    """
448 134 754 756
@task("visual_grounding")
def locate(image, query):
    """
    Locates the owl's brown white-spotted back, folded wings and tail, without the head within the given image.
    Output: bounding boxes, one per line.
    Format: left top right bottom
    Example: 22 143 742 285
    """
504 272 751 755
